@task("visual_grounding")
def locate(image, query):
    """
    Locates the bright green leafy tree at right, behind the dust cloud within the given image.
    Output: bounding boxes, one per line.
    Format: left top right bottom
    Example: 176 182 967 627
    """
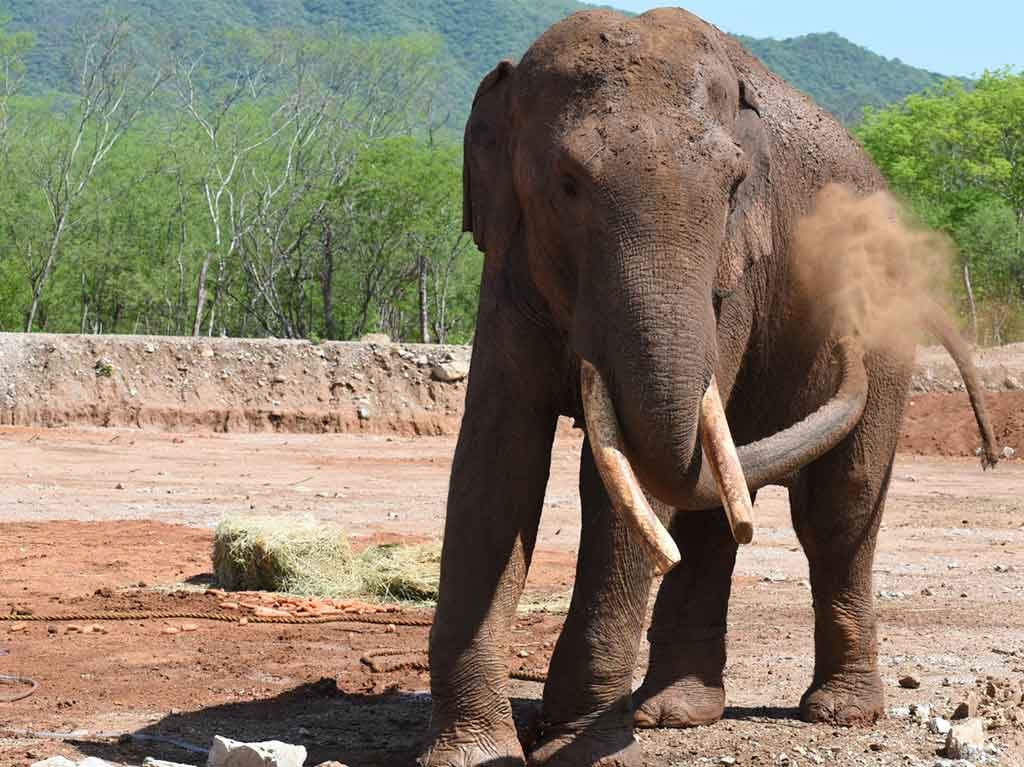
858 70 1024 343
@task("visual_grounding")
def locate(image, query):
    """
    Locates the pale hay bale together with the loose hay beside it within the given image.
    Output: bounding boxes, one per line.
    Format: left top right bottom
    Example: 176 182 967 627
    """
213 516 440 602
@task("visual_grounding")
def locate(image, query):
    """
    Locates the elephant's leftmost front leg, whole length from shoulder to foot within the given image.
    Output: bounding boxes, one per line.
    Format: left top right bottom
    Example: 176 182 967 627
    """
419 319 558 767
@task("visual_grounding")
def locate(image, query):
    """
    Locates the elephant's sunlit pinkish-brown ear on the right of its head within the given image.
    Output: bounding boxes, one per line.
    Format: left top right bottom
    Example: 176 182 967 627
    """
716 81 772 296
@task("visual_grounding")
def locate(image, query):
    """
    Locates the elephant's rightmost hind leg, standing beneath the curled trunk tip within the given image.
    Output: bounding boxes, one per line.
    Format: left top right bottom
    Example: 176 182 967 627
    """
790 351 912 725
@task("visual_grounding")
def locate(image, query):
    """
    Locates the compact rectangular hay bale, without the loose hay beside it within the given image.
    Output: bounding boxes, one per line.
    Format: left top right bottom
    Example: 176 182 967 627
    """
213 517 358 597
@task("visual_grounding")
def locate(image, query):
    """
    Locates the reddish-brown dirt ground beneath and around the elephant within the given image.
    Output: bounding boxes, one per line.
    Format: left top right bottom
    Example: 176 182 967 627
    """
0 423 1024 767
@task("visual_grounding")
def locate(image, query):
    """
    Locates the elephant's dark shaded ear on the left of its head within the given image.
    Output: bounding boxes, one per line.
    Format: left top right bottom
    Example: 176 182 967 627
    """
462 61 521 257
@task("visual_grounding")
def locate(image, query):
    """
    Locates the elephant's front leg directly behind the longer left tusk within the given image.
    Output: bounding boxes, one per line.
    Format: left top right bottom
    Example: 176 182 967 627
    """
530 440 651 767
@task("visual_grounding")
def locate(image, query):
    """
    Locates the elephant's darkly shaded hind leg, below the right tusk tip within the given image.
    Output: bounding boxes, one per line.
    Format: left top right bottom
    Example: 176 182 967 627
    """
633 511 736 728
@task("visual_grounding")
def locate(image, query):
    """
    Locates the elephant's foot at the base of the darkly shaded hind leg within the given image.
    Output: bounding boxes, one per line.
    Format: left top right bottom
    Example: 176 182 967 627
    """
633 637 725 729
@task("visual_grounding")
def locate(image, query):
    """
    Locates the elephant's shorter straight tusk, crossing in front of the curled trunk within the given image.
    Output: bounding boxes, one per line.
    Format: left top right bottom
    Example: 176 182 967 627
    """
700 376 754 544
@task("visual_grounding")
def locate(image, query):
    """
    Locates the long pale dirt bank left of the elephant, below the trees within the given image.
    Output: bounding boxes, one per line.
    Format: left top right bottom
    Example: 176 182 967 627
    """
0 334 469 434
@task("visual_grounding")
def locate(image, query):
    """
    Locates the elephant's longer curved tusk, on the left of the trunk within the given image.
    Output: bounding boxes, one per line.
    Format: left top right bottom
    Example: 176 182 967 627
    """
580 360 682 574
